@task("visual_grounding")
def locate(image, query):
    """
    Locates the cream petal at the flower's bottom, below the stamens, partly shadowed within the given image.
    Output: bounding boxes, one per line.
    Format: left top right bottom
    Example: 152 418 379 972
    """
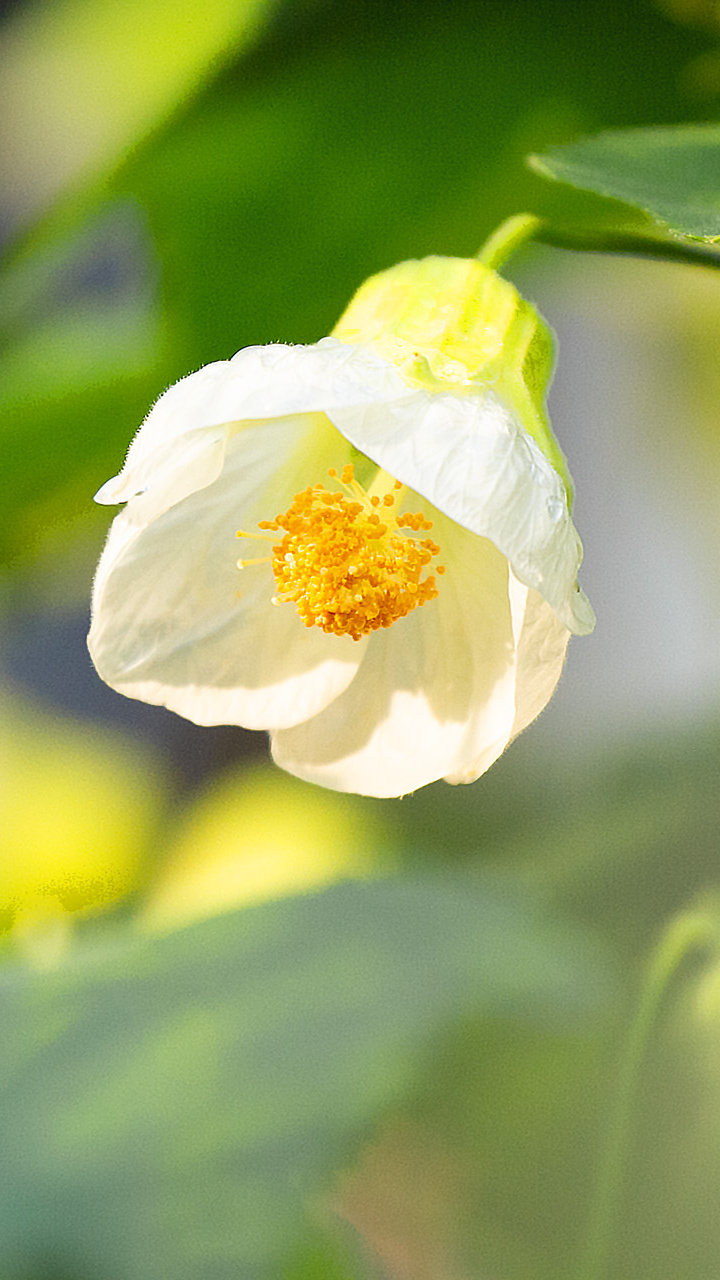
272 506 516 796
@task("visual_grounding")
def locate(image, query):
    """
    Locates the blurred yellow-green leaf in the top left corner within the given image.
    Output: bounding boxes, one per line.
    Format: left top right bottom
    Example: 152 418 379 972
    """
0 0 278 230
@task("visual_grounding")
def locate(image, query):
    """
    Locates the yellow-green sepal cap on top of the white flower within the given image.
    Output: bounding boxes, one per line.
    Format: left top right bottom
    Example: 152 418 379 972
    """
333 257 573 499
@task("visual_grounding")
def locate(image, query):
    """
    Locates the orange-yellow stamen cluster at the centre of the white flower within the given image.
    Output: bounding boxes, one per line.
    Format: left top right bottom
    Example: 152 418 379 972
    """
238 465 445 640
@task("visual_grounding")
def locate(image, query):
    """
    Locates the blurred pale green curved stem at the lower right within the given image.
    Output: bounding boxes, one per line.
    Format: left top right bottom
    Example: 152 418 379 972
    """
577 906 720 1280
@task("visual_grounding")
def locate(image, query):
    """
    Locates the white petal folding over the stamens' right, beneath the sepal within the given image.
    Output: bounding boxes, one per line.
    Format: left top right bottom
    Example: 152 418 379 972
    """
328 389 594 635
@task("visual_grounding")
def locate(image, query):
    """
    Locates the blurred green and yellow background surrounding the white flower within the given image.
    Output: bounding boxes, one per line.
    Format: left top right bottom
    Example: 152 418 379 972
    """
0 0 720 1280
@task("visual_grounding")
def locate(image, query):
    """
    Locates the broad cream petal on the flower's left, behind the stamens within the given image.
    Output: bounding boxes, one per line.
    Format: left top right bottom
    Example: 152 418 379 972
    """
88 413 365 728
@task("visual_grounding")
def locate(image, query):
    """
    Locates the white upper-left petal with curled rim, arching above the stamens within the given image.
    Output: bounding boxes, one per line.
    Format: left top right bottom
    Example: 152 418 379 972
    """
96 338 407 509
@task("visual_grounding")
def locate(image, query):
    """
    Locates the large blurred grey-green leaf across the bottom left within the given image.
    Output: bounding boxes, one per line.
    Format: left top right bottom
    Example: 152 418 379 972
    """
0 878 607 1280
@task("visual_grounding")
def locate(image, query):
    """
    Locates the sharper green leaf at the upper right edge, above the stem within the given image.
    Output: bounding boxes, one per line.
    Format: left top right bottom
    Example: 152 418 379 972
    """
529 124 720 243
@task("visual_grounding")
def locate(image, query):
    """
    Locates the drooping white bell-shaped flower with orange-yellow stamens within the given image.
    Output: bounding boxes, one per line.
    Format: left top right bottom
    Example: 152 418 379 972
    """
88 259 593 796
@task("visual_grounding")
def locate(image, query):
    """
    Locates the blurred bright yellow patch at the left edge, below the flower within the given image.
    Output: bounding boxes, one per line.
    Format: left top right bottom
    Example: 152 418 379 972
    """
0 695 164 932
